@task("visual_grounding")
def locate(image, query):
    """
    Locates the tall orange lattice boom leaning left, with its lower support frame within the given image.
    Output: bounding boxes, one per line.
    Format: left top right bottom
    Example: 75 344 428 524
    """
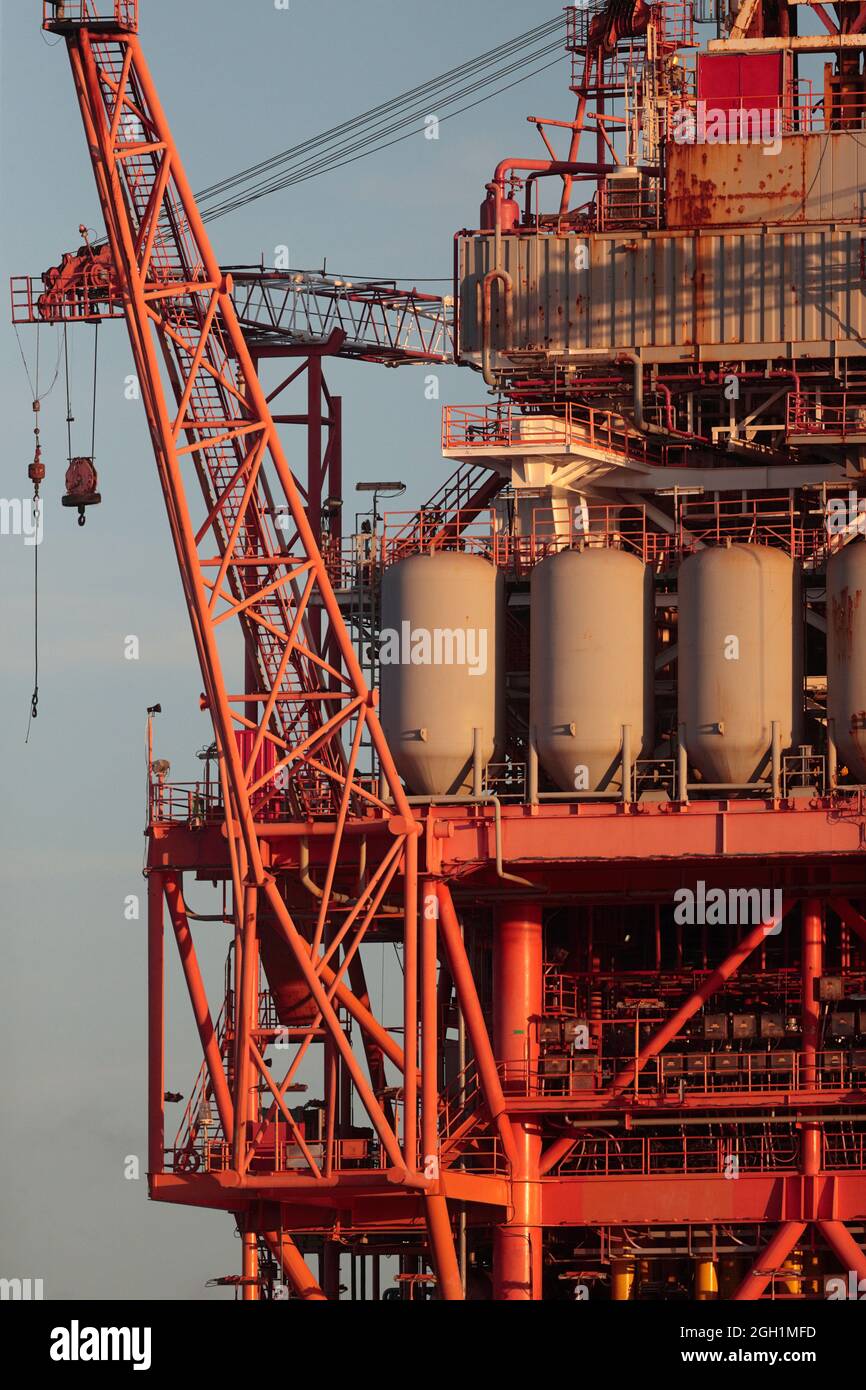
33 0 480 1298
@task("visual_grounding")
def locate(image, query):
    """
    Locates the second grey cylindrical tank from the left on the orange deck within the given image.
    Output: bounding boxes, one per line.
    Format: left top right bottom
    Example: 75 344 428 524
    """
530 546 655 791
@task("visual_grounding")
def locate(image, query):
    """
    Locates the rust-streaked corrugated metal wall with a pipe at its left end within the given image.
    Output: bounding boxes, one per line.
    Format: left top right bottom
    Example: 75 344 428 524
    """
459 227 866 361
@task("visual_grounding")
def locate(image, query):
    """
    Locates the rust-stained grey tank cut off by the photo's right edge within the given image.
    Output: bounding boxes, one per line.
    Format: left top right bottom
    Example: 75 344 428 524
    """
827 541 866 783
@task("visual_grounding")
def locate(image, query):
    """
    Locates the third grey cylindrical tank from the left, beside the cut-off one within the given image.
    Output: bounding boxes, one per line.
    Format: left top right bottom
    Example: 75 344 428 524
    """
677 545 803 783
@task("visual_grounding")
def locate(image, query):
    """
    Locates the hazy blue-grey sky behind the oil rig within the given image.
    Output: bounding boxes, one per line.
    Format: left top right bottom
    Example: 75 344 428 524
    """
0 0 573 1300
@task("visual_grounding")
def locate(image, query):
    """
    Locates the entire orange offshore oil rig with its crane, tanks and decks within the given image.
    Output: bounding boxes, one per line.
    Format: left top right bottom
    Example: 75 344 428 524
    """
13 0 866 1301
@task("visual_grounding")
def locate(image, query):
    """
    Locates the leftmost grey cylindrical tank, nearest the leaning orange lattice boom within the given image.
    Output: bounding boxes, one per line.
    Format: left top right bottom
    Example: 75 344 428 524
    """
379 550 505 796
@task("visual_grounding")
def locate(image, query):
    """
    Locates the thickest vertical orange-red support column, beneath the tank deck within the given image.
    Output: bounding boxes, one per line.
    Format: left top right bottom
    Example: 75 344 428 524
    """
493 902 544 1301
